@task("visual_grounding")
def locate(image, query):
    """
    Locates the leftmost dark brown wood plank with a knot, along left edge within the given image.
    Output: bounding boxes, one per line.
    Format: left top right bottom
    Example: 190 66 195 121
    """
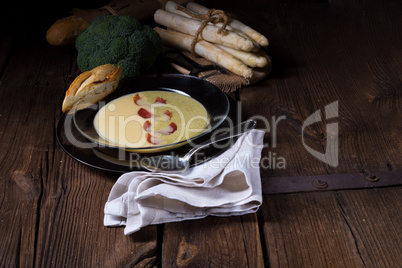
0 17 61 266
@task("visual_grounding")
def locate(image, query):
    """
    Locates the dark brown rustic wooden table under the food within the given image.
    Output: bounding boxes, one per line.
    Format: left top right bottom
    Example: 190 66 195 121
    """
0 0 402 267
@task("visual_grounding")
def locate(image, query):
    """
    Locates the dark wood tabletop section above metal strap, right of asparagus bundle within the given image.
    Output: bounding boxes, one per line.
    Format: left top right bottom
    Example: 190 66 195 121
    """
236 1 402 177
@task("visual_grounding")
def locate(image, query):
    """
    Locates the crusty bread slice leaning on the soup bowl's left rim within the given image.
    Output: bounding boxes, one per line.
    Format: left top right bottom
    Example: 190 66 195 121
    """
62 64 121 113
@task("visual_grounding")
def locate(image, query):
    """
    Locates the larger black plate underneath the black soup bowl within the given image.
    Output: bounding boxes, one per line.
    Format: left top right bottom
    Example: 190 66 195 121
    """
56 75 240 173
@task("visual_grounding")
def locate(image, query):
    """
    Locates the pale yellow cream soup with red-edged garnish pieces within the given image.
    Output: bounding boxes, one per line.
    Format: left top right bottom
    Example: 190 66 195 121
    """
94 91 209 148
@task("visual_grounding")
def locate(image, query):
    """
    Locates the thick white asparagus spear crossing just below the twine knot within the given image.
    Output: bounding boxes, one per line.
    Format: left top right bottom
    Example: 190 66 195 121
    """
154 9 255 51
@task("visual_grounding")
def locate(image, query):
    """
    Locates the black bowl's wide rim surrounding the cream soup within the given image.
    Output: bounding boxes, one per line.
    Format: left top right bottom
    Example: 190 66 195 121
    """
73 75 230 153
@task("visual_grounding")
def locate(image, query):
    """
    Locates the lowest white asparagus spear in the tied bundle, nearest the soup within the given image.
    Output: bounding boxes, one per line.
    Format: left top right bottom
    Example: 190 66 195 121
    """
154 27 253 78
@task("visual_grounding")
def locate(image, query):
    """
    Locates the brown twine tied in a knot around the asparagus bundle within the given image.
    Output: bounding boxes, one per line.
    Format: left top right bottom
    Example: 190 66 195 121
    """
175 5 228 57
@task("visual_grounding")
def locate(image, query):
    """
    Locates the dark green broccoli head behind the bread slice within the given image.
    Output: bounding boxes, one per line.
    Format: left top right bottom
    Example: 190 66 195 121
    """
75 15 162 78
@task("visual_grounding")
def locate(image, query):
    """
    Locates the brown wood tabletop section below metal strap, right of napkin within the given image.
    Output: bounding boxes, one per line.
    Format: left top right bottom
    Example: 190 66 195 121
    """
260 188 402 267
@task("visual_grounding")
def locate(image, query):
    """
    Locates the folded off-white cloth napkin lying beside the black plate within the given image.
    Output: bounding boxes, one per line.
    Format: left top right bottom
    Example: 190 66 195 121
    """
104 130 264 235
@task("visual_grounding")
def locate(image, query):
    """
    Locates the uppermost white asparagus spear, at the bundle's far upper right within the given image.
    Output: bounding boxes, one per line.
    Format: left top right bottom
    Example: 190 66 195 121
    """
186 2 269 47
